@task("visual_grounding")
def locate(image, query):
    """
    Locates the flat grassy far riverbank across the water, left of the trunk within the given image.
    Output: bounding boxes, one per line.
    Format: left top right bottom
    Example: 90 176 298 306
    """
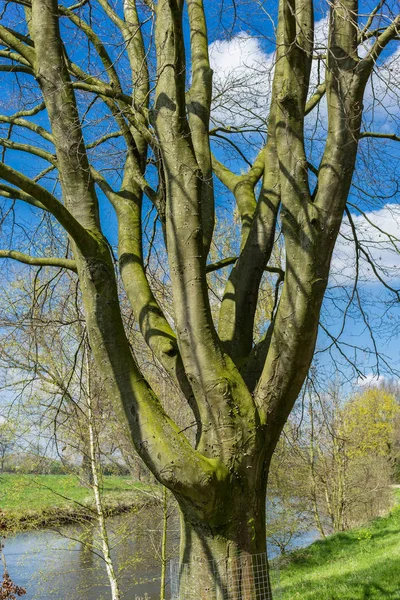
0 474 157 535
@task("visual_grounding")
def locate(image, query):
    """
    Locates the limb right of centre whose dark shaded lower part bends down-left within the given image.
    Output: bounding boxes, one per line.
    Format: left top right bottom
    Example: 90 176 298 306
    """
219 0 313 368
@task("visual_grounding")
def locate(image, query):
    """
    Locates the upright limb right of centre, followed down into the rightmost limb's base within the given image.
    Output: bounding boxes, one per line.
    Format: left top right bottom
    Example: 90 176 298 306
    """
255 0 324 448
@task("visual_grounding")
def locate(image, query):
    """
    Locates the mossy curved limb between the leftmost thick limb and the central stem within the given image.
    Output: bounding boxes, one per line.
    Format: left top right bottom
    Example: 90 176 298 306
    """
93 0 192 422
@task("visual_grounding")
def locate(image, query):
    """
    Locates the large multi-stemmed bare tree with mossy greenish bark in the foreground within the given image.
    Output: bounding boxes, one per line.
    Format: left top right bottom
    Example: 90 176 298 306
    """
0 0 400 599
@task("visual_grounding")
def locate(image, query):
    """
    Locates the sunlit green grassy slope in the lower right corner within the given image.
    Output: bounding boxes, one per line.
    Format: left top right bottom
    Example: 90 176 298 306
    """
280 490 400 600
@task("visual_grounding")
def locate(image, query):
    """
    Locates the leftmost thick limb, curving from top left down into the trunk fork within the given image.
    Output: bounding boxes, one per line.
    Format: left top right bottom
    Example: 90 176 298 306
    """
26 0 216 497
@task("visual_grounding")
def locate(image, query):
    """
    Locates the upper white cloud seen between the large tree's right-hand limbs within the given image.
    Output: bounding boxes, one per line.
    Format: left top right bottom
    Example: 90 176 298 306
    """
210 16 400 135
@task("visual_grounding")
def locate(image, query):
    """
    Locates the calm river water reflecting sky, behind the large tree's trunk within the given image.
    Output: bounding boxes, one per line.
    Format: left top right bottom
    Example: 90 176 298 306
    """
4 508 317 600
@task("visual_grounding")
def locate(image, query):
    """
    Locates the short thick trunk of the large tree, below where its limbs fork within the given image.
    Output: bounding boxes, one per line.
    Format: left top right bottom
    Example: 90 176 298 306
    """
172 487 272 600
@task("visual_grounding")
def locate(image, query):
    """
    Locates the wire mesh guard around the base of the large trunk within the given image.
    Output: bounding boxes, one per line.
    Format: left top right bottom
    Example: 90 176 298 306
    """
170 553 281 600
